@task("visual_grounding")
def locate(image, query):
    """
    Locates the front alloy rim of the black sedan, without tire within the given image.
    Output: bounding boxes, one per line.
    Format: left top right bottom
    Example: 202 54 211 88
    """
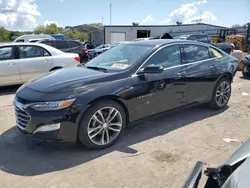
87 107 123 145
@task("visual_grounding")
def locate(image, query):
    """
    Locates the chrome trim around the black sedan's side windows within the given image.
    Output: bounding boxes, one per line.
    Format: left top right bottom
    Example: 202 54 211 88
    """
132 42 222 77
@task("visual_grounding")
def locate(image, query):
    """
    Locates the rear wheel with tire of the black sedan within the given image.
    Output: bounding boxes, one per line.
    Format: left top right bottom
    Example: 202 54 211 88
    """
209 78 231 110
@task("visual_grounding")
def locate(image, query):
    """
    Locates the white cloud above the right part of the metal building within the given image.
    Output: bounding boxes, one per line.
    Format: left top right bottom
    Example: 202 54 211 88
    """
161 0 216 24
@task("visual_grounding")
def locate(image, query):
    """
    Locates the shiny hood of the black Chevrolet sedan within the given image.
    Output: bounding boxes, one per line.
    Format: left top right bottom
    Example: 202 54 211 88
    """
25 67 115 93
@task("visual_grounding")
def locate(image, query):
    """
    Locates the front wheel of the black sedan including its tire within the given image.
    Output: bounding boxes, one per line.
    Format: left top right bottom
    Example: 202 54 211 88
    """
78 100 126 149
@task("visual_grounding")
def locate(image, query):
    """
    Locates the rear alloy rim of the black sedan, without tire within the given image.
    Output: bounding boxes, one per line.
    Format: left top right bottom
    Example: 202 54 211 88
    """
215 81 231 106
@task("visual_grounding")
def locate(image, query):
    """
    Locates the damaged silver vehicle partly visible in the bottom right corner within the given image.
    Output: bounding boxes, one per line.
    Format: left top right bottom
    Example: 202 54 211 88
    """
183 139 250 188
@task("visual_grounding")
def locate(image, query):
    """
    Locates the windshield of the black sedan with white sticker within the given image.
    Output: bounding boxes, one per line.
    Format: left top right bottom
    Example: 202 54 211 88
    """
86 44 152 70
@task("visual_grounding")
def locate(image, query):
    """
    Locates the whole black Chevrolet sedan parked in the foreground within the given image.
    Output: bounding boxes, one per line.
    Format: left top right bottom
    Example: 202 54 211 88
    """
14 39 238 149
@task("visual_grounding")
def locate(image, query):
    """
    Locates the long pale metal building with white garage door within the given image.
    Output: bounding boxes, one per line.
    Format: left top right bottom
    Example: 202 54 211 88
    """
91 23 226 45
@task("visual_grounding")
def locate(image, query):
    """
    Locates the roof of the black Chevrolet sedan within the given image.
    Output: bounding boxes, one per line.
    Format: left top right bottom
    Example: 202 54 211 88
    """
129 39 210 46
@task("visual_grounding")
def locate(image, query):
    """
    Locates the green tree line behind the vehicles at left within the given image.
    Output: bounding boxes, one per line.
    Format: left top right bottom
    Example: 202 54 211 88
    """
0 23 101 42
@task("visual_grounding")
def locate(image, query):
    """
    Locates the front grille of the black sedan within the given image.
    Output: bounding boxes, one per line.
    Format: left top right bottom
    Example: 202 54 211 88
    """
15 106 30 130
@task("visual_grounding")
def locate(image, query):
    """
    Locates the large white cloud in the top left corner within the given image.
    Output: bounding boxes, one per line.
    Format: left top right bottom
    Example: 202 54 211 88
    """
0 0 41 30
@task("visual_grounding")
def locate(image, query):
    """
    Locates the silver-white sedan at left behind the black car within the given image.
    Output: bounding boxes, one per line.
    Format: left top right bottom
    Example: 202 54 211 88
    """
0 43 80 86
